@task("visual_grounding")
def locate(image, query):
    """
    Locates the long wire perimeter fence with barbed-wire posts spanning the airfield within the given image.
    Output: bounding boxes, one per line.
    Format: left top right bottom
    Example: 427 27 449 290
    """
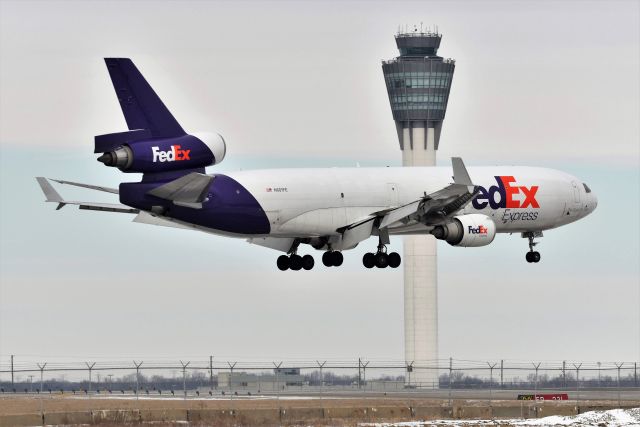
0 356 640 401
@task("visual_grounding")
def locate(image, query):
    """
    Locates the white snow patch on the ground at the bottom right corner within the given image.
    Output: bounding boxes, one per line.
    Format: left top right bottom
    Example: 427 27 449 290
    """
358 408 640 427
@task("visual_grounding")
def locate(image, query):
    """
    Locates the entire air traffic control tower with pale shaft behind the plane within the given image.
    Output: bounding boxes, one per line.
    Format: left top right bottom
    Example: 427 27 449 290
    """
382 29 455 387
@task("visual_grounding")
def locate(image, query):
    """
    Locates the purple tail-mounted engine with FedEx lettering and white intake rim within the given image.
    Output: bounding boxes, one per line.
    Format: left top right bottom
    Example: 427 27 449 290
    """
98 133 227 173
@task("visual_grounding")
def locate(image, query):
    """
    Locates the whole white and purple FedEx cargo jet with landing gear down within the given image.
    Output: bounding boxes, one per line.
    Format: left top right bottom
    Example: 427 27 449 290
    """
37 58 597 270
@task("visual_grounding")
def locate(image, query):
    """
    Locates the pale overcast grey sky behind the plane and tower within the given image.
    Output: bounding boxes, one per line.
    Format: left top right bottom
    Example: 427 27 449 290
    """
0 1 640 372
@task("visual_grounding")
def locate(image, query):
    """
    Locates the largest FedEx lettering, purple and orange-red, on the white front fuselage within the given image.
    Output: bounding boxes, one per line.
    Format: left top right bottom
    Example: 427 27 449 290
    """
472 176 540 209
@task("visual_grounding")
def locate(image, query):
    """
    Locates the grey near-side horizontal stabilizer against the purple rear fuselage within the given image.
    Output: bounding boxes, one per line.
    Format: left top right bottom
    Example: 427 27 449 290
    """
147 172 213 209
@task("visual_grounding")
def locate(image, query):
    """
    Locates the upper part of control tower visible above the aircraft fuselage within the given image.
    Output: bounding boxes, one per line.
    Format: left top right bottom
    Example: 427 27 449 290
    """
382 31 455 166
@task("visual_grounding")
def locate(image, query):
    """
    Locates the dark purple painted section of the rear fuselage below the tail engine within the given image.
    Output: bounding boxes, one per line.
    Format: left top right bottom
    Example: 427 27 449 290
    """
120 175 271 235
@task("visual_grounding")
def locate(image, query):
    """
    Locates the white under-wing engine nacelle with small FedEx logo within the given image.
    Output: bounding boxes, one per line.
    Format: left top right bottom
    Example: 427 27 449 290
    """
431 214 496 248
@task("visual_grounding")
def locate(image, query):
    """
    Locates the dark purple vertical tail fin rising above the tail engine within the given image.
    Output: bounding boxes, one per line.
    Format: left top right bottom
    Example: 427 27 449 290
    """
104 58 185 138
